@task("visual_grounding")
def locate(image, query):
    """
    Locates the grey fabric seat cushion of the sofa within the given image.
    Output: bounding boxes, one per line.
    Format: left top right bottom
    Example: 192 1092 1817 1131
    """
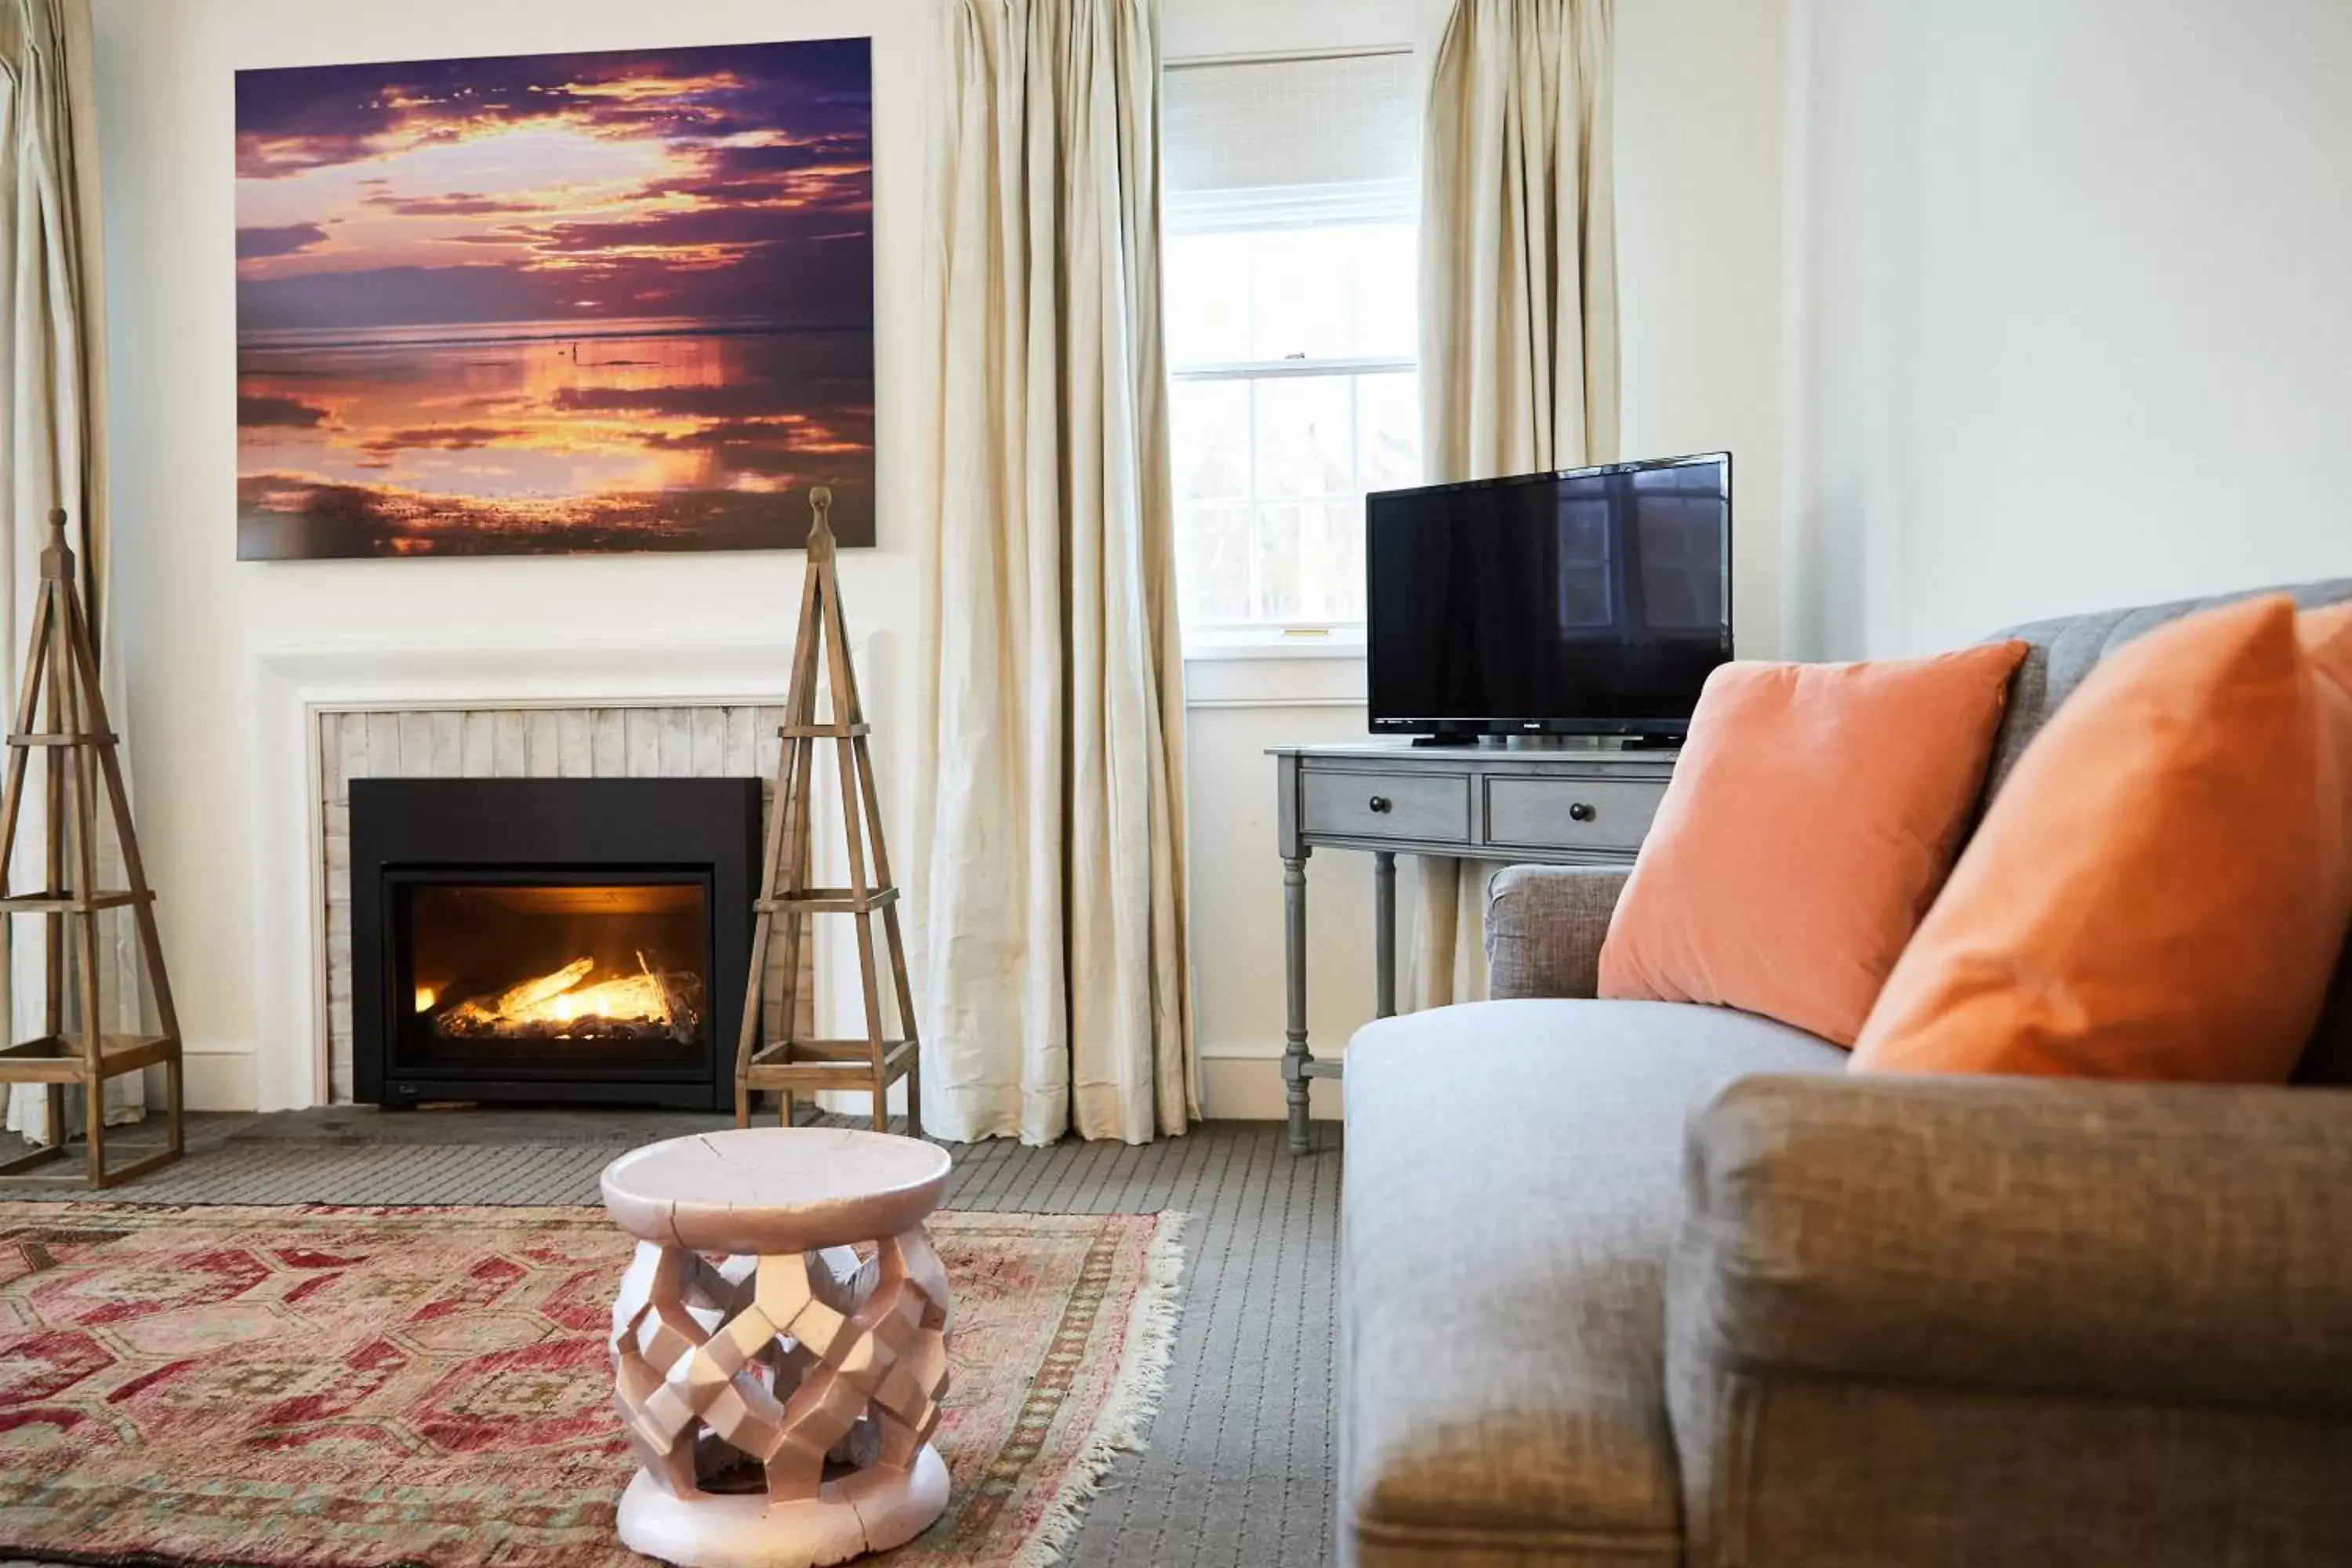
1338 999 1846 1566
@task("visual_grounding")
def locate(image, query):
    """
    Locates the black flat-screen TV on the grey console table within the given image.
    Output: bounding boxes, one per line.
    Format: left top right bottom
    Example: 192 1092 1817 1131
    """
1364 452 1731 741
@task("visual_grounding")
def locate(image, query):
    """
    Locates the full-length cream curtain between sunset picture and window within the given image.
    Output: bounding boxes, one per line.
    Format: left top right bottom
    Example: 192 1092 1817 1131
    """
917 0 1197 1142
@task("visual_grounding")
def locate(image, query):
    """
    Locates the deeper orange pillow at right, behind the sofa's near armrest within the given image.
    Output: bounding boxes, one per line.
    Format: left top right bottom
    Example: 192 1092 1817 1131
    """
1851 595 2352 1083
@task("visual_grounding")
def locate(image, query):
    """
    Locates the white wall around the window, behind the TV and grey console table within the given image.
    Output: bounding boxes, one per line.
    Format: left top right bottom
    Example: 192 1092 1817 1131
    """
1164 0 1783 1116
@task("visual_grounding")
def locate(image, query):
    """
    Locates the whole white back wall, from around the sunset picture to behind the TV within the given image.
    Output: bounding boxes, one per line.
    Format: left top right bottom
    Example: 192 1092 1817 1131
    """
96 0 1780 1114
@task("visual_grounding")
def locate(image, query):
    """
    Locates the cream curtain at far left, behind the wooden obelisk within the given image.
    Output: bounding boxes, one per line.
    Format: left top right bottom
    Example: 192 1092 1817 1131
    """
0 0 146 1138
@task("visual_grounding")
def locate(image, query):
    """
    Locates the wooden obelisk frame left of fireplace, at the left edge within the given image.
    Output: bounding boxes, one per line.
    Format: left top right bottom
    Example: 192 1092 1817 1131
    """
0 510 181 1187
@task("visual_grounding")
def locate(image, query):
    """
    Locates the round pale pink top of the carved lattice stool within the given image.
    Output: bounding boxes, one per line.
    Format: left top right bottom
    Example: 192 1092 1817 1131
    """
600 1126 953 1255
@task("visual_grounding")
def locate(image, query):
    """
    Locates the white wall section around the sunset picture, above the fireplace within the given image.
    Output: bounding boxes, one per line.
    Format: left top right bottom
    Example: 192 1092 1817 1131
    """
96 0 934 1107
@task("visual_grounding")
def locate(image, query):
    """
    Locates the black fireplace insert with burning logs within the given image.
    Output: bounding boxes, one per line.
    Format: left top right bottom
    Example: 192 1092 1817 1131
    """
350 779 760 1109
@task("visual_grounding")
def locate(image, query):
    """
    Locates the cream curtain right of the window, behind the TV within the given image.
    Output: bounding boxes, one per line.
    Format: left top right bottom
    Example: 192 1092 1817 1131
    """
1406 0 1618 1006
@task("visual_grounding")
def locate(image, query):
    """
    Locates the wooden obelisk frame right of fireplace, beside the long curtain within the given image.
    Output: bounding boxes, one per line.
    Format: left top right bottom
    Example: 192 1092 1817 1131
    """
736 485 922 1138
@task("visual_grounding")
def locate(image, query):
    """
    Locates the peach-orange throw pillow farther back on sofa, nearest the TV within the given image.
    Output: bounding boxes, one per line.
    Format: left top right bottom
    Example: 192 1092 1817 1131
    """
1599 642 2025 1046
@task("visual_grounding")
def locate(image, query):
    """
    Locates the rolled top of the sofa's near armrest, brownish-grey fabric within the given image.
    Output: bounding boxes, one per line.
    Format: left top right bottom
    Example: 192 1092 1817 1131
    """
1670 1076 2352 1413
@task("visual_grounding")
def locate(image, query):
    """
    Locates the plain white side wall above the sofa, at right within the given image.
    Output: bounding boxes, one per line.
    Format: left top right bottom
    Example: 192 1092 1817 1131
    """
1788 0 2352 656
